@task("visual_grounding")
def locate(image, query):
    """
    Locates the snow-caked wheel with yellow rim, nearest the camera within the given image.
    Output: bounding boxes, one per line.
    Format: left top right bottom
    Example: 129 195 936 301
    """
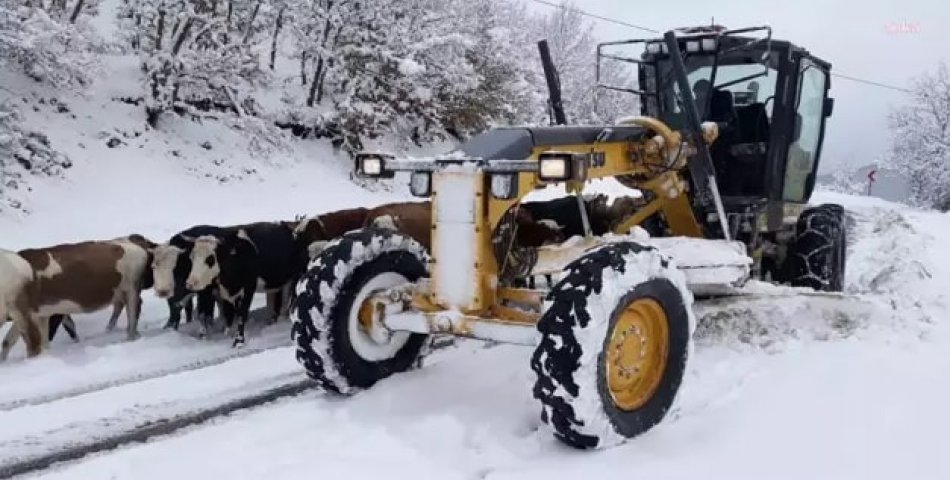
531 242 696 449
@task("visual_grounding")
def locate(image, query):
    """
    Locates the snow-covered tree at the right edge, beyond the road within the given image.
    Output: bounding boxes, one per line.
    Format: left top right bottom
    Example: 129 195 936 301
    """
889 63 950 209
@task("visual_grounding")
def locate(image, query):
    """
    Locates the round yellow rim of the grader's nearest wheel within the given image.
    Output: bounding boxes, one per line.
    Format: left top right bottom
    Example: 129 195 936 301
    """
606 298 670 411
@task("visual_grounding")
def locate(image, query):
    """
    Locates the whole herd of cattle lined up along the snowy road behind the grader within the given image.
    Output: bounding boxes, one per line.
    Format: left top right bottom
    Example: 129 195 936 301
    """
0 195 637 360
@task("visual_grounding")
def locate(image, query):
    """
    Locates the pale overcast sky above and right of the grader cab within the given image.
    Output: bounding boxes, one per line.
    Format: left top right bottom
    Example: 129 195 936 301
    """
526 0 950 171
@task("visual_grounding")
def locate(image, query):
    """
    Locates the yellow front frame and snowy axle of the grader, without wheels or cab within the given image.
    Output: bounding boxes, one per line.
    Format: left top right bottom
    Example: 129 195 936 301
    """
357 117 744 345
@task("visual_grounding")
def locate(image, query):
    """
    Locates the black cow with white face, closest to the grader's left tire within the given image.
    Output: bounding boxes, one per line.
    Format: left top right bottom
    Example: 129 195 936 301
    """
185 222 300 347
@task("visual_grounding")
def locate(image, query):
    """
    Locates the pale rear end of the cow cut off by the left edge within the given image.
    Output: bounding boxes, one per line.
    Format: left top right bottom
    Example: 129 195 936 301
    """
0 249 42 360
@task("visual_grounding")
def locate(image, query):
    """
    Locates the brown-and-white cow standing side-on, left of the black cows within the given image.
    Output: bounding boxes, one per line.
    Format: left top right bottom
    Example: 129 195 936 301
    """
2 238 151 354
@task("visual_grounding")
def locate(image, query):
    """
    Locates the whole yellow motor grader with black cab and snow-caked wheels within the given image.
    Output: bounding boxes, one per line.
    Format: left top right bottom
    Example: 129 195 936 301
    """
293 26 845 448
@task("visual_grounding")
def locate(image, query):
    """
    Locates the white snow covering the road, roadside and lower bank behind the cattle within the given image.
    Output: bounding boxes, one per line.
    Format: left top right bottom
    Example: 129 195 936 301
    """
0 139 950 480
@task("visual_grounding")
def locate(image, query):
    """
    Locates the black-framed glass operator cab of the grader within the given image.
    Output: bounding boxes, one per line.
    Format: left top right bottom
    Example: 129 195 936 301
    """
598 27 832 204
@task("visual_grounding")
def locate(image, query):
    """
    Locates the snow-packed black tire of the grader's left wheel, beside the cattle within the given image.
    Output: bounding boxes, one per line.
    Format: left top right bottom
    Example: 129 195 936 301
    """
291 228 429 395
